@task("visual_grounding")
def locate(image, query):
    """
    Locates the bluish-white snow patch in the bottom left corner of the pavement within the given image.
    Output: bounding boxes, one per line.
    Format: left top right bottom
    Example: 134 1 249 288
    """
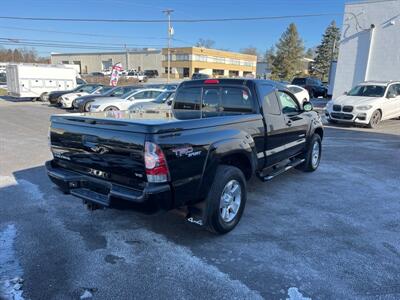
0 224 24 300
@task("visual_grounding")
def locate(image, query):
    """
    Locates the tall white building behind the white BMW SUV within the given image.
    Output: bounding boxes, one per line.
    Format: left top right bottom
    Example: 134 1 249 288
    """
333 0 400 98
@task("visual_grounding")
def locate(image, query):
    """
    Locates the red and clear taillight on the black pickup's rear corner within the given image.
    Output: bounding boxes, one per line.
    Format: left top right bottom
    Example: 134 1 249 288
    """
144 142 169 182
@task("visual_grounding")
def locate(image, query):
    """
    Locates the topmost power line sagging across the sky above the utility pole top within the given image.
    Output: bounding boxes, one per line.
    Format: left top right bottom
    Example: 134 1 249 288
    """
0 13 343 23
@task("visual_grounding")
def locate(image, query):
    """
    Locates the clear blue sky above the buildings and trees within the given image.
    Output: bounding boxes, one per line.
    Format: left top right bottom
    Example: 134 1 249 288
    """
0 0 345 56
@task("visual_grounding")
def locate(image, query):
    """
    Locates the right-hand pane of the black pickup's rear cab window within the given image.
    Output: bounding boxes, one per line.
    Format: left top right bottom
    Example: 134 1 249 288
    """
221 87 254 115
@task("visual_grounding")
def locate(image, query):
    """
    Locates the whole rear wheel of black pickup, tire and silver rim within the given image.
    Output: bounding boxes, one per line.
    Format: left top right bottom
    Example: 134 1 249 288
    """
206 165 247 234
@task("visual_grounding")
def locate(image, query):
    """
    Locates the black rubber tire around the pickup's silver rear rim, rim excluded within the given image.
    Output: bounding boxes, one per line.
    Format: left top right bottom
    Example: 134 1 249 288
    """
206 165 247 234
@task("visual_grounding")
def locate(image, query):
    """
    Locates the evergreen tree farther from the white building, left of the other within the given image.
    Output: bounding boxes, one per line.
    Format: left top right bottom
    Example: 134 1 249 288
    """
271 23 304 81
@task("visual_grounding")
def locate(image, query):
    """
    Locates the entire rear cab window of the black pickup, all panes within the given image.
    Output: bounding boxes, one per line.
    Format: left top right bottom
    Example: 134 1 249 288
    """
174 86 254 118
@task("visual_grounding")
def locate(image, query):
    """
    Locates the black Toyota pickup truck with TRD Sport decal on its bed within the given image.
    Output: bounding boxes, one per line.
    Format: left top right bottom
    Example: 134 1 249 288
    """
46 79 323 233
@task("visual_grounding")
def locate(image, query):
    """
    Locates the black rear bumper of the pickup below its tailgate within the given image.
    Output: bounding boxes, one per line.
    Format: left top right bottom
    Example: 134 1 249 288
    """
46 161 173 210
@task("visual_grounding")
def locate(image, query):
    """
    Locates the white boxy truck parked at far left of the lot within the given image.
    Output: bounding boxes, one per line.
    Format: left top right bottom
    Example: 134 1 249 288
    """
7 64 79 101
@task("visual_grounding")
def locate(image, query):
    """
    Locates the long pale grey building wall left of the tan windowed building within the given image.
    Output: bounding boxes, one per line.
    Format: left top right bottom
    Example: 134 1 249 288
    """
51 50 162 74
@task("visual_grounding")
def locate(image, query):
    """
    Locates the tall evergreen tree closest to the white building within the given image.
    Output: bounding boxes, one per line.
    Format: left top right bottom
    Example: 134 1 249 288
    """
312 21 340 81
